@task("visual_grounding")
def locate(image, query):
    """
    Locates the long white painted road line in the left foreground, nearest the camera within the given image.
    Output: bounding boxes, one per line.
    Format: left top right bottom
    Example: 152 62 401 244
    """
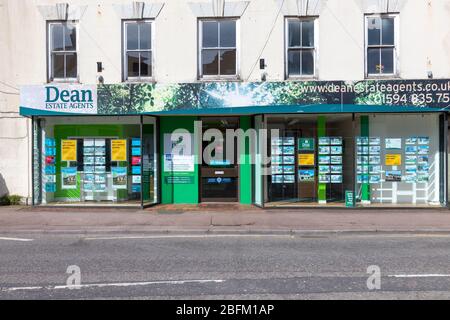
0 280 225 292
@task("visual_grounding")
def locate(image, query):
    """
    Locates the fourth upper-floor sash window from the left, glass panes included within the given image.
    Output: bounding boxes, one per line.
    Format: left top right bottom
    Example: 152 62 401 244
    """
286 18 317 78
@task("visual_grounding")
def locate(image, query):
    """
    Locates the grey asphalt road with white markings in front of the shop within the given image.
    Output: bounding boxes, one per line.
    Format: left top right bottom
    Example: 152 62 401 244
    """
0 234 450 299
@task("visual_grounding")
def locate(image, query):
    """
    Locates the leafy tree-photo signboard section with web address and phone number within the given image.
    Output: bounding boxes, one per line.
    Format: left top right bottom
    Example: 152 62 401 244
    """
97 80 450 114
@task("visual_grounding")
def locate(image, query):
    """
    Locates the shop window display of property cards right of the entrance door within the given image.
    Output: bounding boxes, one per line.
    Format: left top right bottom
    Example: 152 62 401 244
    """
264 113 445 207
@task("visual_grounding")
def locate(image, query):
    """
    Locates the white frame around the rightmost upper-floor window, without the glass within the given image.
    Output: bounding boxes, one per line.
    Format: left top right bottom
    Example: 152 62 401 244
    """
364 13 400 79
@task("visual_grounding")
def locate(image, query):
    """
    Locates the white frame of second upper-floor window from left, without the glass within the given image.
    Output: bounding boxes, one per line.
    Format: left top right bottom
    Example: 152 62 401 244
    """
122 19 155 82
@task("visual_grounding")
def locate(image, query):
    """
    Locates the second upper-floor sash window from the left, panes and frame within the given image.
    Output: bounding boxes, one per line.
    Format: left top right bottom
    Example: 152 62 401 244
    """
123 20 153 80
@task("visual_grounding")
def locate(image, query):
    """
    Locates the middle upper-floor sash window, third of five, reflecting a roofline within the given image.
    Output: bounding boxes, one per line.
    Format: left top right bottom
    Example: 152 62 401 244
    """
199 19 238 79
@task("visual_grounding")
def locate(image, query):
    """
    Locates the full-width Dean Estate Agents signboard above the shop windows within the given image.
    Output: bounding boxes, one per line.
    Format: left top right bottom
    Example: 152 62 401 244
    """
20 79 450 116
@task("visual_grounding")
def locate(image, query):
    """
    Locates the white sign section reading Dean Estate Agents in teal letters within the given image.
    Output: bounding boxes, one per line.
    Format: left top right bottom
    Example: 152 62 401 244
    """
20 85 97 115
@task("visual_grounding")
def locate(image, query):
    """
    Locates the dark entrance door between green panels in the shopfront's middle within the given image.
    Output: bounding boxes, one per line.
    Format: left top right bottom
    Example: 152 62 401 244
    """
200 117 239 202
